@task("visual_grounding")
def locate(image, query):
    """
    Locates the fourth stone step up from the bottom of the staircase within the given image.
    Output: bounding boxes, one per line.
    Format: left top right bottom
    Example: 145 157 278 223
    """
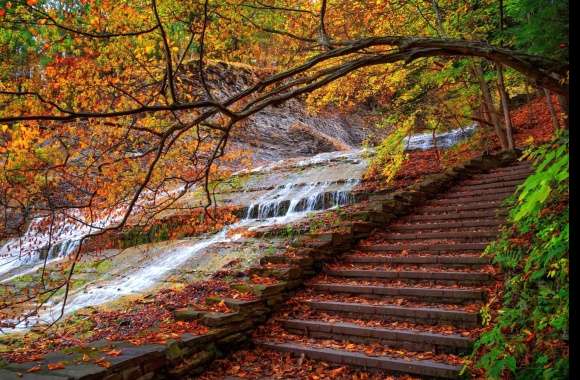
309 284 487 303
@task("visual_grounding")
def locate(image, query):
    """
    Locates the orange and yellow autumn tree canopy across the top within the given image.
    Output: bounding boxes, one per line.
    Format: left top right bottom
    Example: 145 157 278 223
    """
0 0 568 326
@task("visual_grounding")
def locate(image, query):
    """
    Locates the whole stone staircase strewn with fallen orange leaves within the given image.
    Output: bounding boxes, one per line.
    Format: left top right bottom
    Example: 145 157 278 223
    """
254 163 532 378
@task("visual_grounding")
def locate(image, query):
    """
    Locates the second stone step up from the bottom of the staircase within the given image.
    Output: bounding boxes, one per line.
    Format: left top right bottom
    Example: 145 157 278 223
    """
280 319 472 354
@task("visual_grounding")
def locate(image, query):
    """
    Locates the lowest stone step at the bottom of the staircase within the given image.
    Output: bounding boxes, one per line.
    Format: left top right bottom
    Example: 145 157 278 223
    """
258 342 461 379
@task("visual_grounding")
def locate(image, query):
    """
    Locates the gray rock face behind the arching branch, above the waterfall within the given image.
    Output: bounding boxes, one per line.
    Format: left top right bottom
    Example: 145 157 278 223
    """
181 62 367 163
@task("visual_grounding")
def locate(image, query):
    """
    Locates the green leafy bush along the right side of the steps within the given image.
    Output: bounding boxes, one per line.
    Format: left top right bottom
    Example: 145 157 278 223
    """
472 132 569 379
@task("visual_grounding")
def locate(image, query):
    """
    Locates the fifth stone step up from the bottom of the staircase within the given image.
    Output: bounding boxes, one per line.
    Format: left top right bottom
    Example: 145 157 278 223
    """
325 269 493 282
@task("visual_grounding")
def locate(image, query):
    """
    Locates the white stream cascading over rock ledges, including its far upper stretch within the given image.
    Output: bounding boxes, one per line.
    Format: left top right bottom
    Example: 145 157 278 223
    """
0 125 475 332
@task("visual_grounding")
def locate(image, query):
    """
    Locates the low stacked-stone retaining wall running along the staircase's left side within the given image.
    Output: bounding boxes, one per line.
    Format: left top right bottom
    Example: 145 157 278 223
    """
0 153 517 380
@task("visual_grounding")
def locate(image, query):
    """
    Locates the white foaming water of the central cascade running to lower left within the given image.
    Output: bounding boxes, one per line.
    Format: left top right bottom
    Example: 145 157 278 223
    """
4 151 366 332
